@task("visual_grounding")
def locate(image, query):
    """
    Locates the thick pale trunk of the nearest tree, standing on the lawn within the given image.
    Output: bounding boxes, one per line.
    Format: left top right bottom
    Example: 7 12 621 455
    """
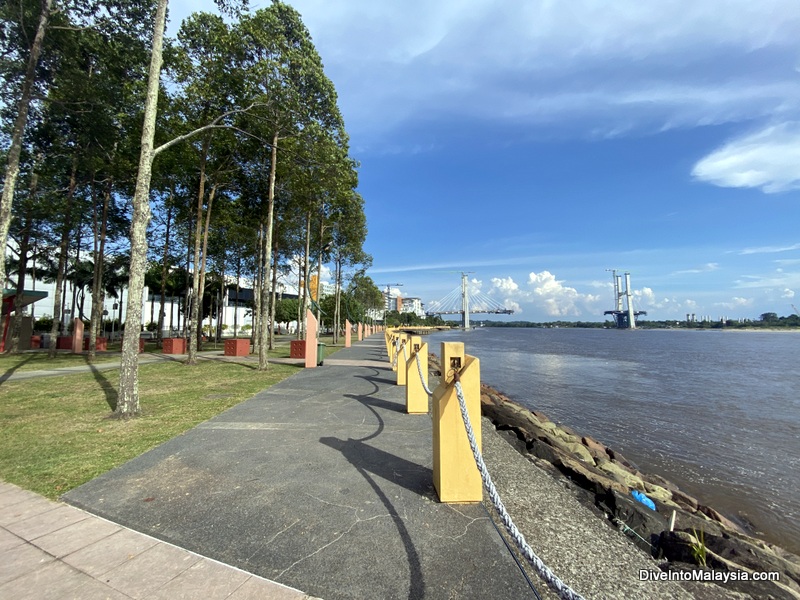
114 0 167 418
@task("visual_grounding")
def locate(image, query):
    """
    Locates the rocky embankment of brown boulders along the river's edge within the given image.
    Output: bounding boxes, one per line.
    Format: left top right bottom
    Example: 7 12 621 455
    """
481 385 800 599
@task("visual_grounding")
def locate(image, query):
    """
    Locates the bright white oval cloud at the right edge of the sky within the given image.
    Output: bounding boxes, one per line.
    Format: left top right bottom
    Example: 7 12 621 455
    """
692 121 800 194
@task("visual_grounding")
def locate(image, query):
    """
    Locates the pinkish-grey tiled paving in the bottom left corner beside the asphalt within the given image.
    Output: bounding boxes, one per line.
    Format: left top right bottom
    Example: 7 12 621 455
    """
0 482 308 600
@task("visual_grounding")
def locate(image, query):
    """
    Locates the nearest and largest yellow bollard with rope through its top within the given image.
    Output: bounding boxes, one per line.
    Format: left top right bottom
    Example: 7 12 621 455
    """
431 342 483 503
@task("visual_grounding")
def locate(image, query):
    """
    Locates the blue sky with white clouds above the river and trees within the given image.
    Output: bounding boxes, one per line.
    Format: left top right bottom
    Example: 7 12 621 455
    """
169 0 800 322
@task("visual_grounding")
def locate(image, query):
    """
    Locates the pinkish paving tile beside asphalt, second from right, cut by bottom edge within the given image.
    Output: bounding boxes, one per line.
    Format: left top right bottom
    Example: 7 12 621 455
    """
150 558 250 600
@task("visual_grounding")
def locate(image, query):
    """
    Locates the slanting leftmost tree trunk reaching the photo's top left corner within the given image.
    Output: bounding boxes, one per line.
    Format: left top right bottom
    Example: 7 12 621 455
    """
0 0 53 298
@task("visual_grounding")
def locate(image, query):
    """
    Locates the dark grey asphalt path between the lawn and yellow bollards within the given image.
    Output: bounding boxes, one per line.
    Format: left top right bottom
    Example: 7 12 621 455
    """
64 336 544 600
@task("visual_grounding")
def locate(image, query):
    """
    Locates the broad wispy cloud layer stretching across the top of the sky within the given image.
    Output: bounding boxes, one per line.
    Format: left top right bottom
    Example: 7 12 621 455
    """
170 0 800 145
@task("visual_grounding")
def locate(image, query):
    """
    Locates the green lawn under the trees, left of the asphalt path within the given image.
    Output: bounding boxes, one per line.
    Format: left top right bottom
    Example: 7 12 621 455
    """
0 345 336 499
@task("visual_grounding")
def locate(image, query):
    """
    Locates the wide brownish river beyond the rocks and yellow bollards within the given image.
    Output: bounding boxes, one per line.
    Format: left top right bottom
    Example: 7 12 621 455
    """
425 327 800 554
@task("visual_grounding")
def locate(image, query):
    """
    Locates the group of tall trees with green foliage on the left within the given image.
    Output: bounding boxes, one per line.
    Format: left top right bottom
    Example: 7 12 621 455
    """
0 0 371 416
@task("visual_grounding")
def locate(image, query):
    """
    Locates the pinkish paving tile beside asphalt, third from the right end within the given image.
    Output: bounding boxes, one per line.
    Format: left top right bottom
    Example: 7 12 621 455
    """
101 544 200 598
